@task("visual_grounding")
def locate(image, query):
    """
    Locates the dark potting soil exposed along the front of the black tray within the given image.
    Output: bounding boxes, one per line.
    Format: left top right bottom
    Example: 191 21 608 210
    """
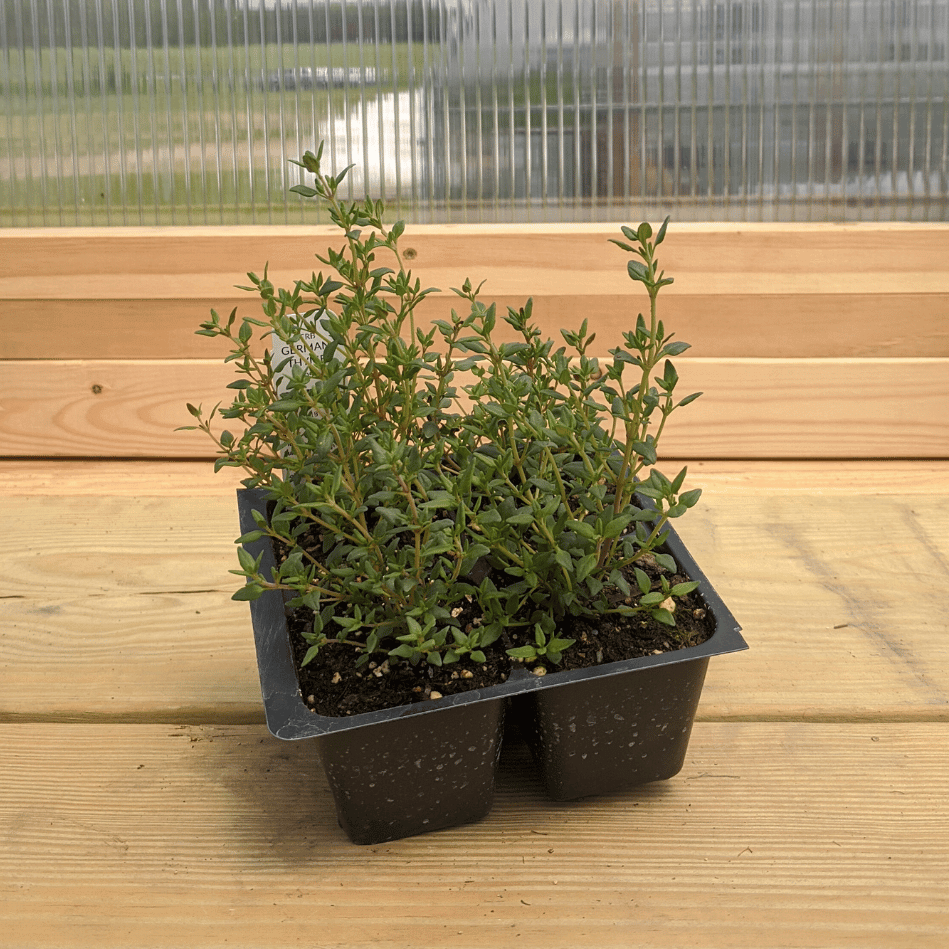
288 565 714 717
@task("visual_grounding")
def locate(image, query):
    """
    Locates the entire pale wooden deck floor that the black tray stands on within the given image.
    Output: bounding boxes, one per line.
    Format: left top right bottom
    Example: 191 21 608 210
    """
0 459 949 949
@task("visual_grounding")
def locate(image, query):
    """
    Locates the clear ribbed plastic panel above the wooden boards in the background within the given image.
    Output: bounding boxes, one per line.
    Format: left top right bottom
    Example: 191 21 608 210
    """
0 0 949 226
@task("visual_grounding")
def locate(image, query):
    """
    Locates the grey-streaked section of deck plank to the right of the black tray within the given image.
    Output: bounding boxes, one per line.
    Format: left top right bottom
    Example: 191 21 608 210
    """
679 492 949 721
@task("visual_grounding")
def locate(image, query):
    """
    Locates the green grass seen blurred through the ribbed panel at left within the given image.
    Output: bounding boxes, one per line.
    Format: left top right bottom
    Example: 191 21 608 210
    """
0 43 424 226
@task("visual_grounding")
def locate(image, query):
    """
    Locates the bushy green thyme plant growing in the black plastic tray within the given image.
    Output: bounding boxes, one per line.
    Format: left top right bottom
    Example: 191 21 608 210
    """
187 148 700 665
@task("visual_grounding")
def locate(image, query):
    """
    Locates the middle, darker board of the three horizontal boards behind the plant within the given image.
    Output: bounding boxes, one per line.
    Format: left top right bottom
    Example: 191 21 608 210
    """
7 288 949 359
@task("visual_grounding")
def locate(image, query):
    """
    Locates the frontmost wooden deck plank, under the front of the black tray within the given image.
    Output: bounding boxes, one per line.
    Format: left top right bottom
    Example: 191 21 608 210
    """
0 723 949 949
